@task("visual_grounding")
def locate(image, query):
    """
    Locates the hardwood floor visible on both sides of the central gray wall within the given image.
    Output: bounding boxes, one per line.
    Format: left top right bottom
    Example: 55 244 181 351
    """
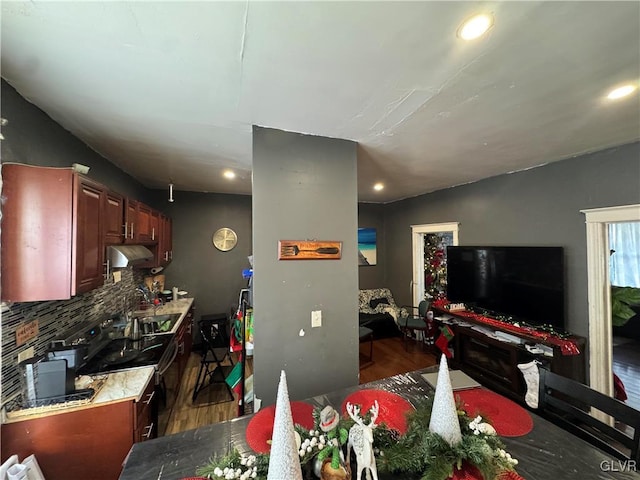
159 337 436 435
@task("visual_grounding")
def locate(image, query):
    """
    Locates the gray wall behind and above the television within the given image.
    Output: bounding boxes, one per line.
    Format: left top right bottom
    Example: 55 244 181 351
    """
384 143 640 336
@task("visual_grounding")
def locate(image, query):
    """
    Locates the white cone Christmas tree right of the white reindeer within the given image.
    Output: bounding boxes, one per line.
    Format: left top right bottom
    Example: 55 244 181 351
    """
429 354 462 446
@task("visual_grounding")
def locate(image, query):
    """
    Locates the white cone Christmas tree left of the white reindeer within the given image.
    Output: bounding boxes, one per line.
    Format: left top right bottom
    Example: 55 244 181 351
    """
267 370 302 480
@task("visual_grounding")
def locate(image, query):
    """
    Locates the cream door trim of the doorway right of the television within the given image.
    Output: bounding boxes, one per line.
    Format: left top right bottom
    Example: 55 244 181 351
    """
581 204 640 396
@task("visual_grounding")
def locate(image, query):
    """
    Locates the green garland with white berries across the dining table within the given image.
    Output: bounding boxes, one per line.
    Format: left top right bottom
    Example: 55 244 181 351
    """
196 399 517 480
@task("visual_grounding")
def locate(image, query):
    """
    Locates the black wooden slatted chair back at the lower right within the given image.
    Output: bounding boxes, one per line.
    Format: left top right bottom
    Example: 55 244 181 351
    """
538 367 640 462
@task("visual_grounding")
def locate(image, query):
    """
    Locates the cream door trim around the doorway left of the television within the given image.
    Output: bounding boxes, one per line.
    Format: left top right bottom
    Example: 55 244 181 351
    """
410 222 460 305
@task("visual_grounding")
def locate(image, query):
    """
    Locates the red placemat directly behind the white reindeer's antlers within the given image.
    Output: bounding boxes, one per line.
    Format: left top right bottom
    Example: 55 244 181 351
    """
342 390 413 434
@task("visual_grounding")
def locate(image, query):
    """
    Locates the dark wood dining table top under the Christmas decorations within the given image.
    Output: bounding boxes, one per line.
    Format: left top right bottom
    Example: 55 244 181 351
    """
119 368 640 480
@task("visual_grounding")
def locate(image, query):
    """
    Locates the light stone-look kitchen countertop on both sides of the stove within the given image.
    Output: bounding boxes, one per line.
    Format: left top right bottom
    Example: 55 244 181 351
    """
1 298 194 423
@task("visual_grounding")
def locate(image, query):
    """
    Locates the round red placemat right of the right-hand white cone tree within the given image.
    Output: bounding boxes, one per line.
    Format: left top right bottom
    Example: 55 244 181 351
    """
455 388 533 437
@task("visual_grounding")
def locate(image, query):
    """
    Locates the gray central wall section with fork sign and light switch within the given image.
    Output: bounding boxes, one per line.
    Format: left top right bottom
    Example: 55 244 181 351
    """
253 127 358 404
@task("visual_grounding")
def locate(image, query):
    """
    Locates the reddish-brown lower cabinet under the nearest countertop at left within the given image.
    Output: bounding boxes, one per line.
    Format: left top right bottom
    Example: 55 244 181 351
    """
1 378 157 480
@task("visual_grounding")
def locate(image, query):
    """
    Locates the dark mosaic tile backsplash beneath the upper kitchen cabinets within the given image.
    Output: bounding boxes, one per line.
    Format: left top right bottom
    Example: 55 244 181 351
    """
1 267 144 404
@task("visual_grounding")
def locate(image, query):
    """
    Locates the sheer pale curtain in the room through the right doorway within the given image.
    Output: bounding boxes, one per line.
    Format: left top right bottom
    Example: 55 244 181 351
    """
609 222 640 288
